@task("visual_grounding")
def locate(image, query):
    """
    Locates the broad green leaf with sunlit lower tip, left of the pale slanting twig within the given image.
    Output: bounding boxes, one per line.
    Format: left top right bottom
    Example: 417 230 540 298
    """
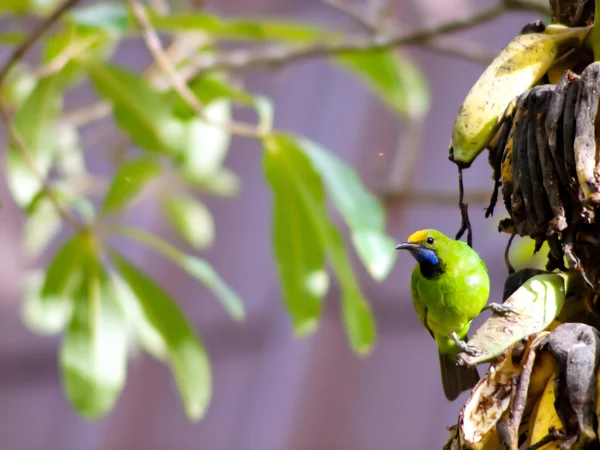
86 63 187 154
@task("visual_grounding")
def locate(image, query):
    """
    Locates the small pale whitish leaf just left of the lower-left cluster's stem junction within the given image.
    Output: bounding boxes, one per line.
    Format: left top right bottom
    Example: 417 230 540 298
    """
23 197 62 259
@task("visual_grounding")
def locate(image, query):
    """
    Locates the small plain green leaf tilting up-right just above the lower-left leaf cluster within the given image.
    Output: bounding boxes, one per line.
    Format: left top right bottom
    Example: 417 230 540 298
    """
102 157 162 214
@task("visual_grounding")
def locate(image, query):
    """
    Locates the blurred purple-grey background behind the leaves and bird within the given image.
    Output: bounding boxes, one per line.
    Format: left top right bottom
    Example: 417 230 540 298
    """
0 0 542 450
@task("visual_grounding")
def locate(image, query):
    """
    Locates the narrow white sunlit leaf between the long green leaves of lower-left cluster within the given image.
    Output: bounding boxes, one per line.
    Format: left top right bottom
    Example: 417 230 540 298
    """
110 272 167 361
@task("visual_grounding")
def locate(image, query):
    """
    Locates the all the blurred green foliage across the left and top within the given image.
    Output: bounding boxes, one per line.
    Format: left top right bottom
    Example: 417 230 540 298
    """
0 0 429 420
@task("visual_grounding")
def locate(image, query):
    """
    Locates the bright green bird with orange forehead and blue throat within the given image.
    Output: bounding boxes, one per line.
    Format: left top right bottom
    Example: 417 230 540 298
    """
396 230 508 401
